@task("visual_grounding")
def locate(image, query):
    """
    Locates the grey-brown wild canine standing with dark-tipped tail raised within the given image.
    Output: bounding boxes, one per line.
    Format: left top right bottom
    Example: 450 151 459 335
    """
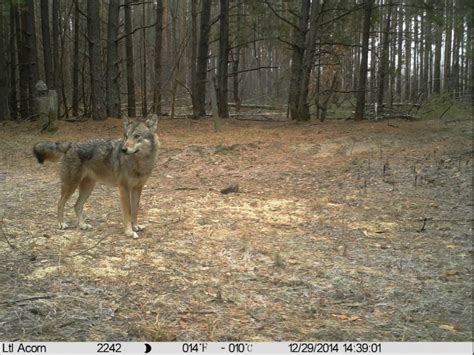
33 115 159 238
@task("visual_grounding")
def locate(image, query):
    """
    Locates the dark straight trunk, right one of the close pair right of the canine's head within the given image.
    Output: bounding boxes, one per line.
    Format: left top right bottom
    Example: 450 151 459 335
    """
217 0 229 118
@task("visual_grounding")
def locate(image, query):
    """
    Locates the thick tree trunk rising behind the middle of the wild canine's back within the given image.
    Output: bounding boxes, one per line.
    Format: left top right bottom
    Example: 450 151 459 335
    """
87 0 107 120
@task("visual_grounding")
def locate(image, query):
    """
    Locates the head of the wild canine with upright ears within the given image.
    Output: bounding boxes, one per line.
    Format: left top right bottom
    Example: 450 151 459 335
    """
121 114 158 155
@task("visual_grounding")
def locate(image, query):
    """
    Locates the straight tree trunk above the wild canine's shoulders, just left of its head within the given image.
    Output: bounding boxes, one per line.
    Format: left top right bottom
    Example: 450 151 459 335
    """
106 0 120 117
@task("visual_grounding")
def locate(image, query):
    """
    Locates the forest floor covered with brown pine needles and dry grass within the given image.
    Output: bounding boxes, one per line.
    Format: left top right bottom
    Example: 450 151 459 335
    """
0 118 473 341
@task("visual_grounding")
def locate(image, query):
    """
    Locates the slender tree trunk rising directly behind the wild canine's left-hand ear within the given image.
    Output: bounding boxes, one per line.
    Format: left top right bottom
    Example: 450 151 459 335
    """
125 0 136 117
